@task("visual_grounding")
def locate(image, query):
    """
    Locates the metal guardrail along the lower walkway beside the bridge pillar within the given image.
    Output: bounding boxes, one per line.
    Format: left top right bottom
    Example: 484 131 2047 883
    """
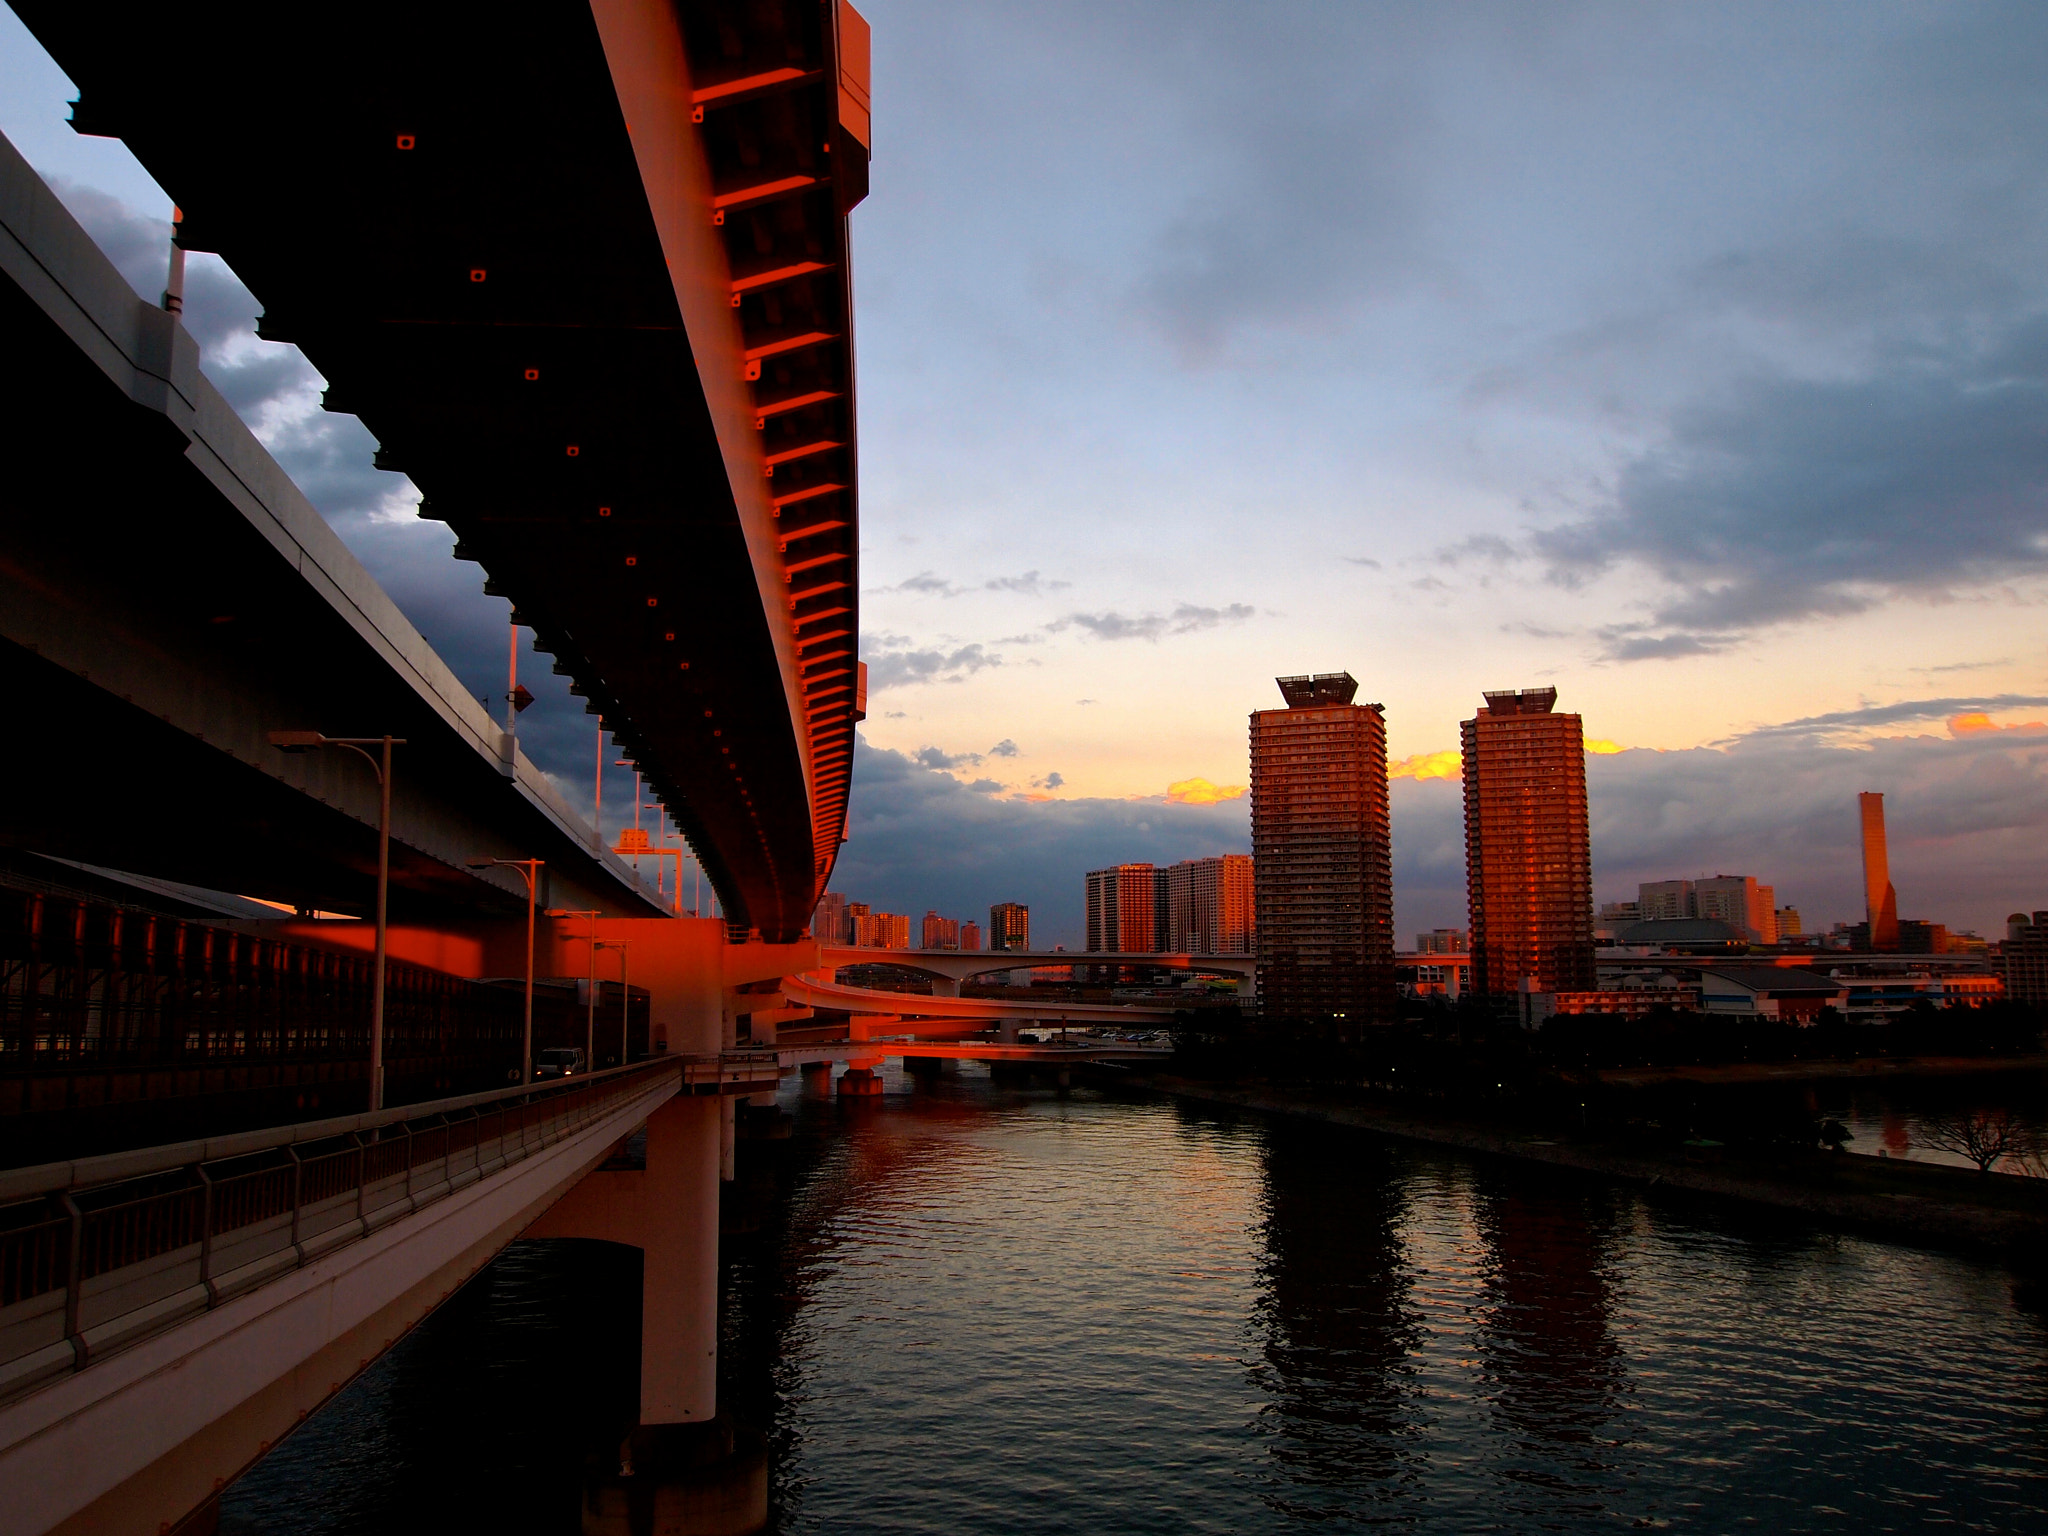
0 1057 690 1401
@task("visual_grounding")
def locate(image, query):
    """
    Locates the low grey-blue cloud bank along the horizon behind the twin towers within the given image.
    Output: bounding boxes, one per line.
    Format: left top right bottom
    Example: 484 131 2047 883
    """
834 729 2048 948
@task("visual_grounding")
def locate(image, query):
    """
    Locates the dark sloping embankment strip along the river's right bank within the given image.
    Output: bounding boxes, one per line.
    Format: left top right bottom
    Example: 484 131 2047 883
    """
1120 1075 2048 1272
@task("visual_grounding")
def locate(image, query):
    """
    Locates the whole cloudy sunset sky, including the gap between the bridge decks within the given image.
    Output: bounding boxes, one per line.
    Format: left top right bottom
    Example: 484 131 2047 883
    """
0 0 2048 946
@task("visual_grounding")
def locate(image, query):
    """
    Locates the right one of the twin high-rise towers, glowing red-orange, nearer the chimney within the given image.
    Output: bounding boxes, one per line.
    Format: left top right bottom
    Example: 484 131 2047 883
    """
1460 688 1595 995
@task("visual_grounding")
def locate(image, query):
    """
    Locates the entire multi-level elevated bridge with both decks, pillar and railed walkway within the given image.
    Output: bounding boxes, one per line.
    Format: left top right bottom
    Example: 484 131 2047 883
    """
0 0 901 1532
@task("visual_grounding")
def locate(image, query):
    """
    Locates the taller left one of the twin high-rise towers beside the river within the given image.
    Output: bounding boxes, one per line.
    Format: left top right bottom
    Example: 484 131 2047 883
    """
1251 672 1395 1022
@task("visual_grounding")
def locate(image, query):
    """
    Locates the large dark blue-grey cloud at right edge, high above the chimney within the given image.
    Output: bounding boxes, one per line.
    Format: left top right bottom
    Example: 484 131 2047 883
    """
1534 315 2048 662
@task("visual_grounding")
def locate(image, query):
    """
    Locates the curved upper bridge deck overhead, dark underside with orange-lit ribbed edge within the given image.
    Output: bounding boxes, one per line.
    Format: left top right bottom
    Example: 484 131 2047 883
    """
16 0 868 938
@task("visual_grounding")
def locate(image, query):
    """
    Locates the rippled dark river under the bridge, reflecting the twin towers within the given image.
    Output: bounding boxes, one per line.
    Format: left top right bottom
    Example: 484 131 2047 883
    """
223 1067 2048 1536
